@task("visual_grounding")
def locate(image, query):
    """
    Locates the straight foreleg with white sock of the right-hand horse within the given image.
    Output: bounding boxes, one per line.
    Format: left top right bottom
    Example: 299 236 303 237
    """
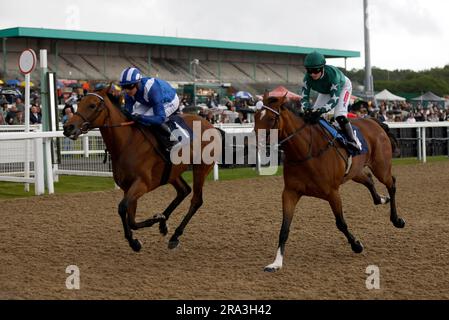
264 188 301 272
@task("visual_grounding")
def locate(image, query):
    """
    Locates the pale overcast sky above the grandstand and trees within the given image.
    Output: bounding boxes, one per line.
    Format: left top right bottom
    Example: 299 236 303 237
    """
0 0 449 70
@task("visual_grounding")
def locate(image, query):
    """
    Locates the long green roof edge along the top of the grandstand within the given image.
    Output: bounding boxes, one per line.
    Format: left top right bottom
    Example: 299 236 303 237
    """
0 27 360 58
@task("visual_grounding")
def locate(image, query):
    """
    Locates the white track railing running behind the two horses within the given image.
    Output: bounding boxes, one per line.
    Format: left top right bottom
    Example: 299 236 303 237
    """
0 121 449 195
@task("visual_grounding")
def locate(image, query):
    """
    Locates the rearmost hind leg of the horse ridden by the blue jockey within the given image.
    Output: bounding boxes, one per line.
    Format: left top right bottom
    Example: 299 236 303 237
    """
168 165 213 249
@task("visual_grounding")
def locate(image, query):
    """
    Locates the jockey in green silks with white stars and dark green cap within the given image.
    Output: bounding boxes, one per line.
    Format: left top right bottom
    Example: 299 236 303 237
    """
301 51 361 150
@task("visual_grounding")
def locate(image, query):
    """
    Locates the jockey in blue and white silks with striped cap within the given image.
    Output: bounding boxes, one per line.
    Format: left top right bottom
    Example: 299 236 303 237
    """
120 67 179 151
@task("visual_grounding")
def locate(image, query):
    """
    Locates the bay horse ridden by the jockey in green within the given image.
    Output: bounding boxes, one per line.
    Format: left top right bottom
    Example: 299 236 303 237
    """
255 95 405 272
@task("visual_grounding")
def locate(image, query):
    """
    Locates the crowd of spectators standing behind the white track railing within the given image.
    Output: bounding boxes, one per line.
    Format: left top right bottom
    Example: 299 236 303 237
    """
0 90 449 125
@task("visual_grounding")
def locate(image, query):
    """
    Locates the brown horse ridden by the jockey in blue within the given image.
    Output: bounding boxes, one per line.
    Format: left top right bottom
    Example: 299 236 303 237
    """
64 87 220 252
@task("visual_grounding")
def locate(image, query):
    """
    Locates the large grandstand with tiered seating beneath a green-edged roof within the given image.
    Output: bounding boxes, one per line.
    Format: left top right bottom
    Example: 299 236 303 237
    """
0 27 360 92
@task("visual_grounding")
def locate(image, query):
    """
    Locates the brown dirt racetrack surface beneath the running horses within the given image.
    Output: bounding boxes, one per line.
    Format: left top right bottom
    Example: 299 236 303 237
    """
0 162 449 299
